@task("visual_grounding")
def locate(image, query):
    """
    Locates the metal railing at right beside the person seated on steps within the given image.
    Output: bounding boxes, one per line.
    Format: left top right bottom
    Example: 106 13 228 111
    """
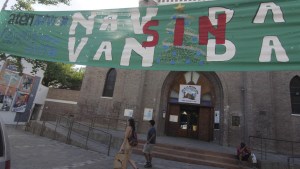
249 136 300 166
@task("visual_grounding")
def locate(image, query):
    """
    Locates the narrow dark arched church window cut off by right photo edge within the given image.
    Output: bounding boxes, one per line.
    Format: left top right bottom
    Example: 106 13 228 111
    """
290 76 300 114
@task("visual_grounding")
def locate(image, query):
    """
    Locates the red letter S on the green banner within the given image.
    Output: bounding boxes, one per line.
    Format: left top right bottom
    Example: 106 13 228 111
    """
142 20 159 48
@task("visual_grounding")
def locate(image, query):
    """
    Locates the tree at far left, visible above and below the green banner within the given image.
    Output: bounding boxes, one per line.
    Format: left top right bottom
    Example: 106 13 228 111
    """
0 0 70 75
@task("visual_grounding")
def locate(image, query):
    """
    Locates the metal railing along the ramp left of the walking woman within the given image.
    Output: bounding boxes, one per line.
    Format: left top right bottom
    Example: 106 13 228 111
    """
40 115 112 156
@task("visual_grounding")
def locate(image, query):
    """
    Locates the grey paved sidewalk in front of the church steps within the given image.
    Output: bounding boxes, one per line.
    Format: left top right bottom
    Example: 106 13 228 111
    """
7 126 223 169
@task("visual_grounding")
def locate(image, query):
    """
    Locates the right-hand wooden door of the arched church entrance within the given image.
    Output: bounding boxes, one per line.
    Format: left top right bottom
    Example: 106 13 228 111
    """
198 107 214 141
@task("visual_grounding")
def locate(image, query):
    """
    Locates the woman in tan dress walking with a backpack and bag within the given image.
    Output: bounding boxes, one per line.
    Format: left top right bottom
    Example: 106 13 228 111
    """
119 118 138 169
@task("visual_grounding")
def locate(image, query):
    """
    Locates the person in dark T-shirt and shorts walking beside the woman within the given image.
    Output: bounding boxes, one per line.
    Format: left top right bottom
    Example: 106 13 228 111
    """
143 120 156 168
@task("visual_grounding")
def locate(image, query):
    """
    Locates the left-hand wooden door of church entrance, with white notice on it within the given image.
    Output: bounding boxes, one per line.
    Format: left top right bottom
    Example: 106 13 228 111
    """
165 104 180 136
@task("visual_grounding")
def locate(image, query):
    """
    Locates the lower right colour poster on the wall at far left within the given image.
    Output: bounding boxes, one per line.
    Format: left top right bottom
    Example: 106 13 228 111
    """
11 92 29 113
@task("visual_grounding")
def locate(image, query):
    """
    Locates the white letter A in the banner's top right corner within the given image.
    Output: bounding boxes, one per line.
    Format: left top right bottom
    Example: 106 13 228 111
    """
253 2 285 23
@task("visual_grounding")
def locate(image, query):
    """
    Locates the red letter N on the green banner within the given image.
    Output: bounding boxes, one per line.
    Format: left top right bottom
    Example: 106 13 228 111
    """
199 14 226 45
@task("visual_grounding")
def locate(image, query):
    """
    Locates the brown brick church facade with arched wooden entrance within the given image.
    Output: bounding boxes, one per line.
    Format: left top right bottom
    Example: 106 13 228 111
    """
78 0 300 154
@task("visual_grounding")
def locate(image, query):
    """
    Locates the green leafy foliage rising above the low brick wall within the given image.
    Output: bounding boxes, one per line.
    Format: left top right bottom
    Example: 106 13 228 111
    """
42 62 85 90
